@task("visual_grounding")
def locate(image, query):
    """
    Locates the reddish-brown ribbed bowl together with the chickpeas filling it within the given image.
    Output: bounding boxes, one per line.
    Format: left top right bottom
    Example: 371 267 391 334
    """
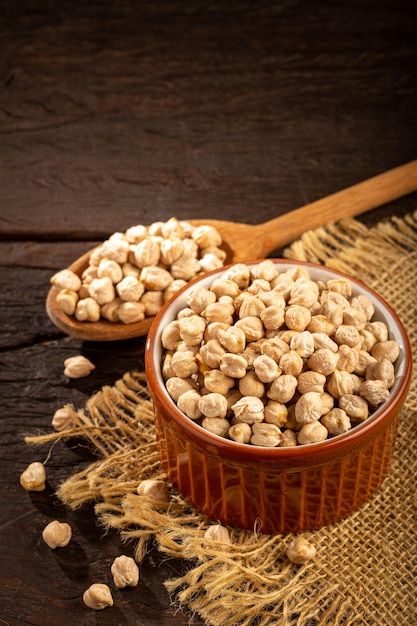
146 259 411 532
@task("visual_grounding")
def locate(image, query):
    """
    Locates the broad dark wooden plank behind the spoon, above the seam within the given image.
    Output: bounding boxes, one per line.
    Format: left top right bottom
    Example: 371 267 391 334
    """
0 2 417 239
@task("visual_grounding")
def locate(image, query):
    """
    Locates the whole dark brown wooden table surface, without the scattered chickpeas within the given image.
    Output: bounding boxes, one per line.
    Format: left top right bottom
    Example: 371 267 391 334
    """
0 0 417 626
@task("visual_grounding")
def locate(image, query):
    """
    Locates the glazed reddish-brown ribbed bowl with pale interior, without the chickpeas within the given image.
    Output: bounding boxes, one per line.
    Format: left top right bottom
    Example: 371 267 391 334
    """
145 259 412 533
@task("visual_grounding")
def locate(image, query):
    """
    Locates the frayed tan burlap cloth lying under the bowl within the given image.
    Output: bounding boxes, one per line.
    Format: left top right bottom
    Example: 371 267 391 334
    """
27 211 417 626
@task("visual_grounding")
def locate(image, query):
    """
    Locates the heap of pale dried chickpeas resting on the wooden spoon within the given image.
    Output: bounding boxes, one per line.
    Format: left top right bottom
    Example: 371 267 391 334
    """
51 217 226 324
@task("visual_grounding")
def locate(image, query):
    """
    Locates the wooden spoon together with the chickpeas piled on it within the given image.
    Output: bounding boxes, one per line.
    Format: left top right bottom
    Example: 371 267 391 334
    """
46 160 417 341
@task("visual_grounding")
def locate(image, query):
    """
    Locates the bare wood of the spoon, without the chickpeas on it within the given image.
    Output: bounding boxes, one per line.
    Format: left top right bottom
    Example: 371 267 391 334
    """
46 160 417 341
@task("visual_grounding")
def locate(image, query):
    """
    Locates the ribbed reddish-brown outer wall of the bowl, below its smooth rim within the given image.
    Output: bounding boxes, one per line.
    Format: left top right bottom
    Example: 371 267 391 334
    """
155 390 397 533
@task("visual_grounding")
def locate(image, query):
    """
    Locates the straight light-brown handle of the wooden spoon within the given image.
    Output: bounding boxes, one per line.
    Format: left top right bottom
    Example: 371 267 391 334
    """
258 160 417 254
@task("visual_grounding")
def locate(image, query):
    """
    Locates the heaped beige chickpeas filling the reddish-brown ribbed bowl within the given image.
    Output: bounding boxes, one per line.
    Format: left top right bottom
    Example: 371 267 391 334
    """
161 259 400 447
